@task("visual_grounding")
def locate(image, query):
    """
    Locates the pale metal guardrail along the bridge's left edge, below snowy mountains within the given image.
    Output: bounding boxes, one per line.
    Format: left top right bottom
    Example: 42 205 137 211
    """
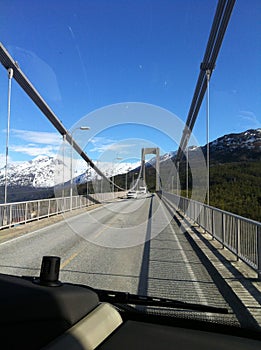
0 192 125 229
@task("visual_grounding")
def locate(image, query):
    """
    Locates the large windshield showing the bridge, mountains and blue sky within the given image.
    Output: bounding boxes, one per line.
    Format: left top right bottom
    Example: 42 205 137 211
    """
0 0 261 330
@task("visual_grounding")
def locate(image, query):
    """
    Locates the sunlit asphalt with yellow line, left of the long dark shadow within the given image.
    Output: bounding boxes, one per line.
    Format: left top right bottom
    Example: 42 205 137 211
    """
0 197 160 292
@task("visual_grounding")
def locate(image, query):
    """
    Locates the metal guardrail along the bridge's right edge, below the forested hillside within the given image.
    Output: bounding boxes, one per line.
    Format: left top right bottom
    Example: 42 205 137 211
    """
162 192 261 279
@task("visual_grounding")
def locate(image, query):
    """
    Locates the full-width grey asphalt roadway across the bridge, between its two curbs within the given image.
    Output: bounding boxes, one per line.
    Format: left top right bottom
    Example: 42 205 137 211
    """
0 196 254 328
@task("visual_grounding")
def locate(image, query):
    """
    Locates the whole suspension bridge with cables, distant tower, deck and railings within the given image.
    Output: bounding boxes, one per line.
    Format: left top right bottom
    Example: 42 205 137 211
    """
0 0 261 328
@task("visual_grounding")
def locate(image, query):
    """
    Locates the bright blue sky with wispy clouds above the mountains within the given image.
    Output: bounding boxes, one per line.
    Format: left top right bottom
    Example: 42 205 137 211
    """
0 0 261 166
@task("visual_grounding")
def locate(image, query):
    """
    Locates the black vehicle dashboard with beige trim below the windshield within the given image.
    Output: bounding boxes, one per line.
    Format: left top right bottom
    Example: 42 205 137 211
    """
0 256 261 350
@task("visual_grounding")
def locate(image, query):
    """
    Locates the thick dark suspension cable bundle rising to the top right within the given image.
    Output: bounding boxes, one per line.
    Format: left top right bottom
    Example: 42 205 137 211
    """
175 0 235 164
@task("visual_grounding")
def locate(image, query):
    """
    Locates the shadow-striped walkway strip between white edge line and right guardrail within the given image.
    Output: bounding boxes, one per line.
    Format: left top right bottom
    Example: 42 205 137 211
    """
158 197 261 328
